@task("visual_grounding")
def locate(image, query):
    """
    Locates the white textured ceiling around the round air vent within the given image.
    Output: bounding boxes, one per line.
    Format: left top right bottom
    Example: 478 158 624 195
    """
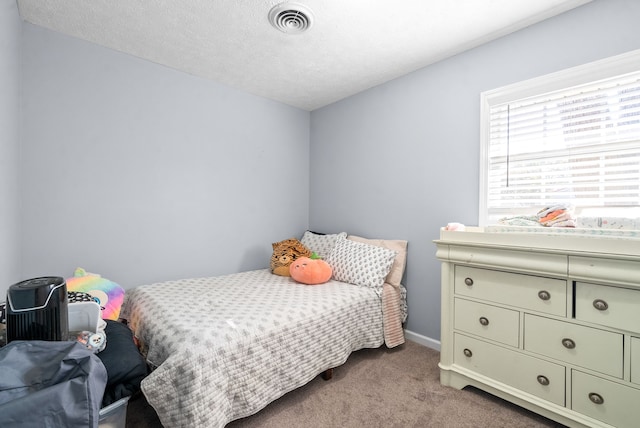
18 0 591 110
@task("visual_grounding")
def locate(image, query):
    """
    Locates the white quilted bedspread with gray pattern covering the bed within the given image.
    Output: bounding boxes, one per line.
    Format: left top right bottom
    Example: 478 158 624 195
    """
121 269 383 427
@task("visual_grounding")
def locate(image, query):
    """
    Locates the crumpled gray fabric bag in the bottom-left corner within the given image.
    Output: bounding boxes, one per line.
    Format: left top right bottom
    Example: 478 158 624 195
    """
0 340 107 428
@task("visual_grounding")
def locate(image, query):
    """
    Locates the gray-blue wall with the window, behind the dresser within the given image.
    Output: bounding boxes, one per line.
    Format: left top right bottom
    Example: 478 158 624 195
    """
310 0 640 340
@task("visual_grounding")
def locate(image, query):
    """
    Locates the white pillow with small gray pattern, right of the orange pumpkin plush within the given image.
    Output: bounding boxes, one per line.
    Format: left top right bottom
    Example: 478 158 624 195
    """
327 236 396 288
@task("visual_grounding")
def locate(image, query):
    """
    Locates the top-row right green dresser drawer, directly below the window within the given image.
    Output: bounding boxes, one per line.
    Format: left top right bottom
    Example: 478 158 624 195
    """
576 282 640 333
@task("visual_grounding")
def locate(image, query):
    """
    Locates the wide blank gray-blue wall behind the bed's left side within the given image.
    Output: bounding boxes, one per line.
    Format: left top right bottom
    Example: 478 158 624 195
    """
20 23 310 288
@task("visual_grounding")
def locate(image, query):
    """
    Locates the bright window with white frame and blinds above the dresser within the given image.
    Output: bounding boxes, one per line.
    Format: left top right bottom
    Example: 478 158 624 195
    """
479 50 640 225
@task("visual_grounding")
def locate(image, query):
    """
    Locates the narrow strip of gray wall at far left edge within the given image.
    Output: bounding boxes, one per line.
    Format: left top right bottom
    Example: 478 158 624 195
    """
0 0 21 302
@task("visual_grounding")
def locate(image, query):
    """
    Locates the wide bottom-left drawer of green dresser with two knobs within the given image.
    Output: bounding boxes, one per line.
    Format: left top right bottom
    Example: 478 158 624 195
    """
453 334 565 406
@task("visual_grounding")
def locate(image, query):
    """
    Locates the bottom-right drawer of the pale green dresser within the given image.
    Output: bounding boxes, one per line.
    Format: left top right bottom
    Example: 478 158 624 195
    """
571 370 640 428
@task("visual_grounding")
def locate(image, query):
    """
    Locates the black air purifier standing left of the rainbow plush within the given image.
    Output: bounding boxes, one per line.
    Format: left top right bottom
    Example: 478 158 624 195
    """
6 276 69 343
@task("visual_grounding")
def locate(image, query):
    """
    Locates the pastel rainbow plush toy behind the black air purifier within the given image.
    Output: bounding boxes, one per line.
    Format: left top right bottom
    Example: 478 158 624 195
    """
66 268 124 320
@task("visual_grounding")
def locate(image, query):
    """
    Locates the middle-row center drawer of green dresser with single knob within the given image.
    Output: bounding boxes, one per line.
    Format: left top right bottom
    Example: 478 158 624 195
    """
524 314 623 378
